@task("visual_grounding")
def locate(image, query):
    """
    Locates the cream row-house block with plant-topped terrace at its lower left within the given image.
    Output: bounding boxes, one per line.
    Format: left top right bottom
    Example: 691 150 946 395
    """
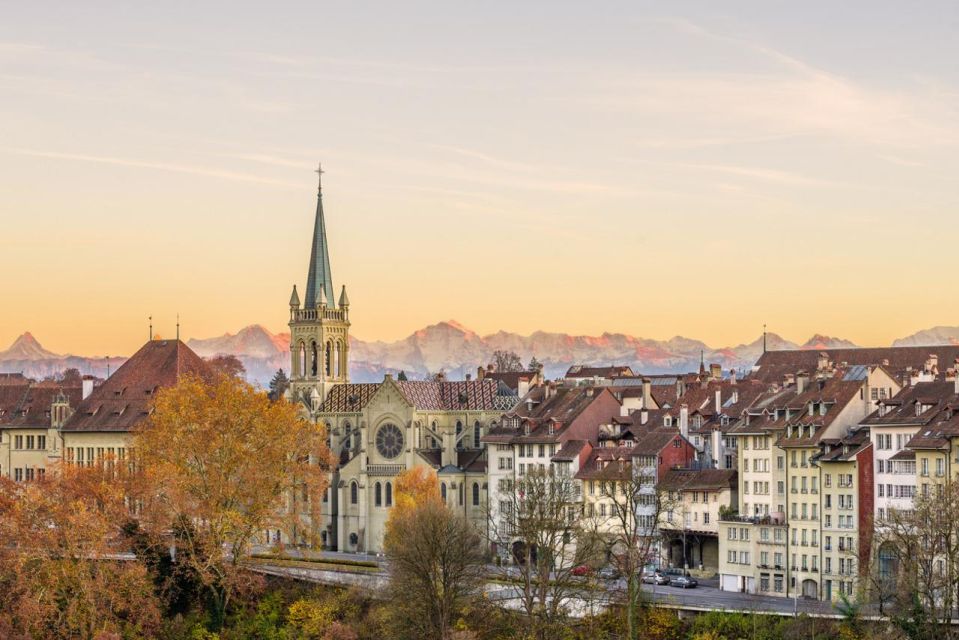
720 362 900 599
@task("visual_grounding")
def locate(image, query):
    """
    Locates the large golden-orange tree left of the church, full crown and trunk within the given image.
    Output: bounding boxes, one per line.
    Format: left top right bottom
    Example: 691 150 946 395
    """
132 376 331 626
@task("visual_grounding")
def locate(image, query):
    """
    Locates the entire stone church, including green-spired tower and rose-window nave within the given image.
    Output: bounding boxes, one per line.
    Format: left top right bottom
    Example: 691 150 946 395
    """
288 168 518 553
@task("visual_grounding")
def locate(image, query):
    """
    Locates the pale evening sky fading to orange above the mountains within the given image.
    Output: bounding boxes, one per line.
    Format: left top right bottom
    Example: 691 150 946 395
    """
0 0 959 355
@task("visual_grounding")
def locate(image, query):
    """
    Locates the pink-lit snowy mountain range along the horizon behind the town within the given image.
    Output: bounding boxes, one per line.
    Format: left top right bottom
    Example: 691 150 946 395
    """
0 320 959 385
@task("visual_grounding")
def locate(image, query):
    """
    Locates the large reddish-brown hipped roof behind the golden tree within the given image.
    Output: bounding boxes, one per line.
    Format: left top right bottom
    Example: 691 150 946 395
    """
63 340 214 431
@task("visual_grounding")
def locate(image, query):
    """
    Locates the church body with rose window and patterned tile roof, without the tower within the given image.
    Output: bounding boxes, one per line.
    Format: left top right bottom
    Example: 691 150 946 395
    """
312 375 517 553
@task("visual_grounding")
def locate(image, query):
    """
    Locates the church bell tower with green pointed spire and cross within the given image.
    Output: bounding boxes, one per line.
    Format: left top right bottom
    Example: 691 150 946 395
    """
290 167 350 409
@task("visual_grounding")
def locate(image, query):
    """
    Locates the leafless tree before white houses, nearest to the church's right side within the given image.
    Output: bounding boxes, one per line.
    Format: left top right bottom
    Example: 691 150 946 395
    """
488 468 600 639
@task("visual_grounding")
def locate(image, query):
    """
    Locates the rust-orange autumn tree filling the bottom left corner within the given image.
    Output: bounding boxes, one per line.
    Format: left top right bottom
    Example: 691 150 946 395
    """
0 467 160 639
